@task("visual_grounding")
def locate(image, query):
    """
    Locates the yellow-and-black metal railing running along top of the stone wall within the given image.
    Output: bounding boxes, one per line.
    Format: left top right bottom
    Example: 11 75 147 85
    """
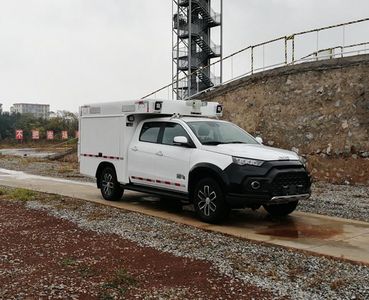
143 18 369 99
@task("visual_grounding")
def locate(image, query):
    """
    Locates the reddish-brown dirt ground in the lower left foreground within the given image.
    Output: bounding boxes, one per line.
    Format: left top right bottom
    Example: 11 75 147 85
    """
0 194 275 299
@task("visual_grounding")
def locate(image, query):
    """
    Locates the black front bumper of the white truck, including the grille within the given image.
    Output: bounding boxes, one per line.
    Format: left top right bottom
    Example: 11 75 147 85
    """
225 161 311 208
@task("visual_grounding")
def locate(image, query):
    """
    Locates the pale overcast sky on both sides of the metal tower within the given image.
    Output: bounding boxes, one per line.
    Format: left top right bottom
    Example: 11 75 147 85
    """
0 0 369 111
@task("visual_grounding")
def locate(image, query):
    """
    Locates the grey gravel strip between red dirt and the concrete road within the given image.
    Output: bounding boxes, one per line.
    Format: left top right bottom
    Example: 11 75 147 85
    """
0 190 369 299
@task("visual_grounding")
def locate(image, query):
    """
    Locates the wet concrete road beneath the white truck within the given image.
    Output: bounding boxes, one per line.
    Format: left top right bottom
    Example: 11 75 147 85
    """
0 169 369 264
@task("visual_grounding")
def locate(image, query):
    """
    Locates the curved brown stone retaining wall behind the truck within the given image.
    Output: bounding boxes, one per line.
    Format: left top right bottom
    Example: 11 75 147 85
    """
200 55 369 157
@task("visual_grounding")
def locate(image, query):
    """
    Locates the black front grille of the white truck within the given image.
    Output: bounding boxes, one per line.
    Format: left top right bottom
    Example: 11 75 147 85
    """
272 172 310 196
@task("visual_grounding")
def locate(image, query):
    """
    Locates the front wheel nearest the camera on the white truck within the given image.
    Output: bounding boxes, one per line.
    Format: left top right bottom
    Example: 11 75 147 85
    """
193 177 230 224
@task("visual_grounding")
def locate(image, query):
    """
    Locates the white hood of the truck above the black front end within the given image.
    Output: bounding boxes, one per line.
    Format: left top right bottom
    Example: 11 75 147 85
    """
203 144 299 161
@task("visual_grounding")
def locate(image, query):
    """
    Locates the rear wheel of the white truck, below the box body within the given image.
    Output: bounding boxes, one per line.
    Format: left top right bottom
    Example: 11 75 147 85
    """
100 167 124 201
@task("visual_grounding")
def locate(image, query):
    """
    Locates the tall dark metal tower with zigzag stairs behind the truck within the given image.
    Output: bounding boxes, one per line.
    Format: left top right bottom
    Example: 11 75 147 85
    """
172 0 223 99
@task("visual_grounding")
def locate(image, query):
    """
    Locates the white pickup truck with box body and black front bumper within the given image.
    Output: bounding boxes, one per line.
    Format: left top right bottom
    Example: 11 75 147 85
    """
79 99 311 223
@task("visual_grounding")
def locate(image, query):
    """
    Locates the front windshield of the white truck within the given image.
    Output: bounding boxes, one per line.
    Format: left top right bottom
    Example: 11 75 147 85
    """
187 121 258 145
